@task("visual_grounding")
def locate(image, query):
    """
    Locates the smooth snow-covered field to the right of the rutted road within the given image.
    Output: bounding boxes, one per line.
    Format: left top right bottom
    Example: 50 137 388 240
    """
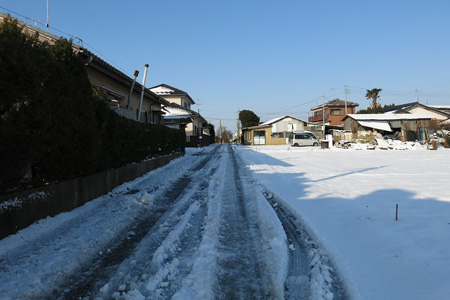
235 145 450 300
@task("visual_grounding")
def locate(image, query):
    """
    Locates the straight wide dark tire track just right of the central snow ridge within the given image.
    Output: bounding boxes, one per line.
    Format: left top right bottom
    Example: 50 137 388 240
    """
216 147 265 299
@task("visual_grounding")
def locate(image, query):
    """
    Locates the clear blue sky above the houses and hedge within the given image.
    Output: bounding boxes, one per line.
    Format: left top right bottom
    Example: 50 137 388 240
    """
0 0 450 131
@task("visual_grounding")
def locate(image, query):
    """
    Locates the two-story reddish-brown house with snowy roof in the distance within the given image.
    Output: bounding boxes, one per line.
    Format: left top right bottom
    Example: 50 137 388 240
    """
308 99 359 126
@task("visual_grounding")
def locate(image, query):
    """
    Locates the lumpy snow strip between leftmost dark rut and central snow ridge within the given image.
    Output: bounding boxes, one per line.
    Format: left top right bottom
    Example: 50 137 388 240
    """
95 163 215 299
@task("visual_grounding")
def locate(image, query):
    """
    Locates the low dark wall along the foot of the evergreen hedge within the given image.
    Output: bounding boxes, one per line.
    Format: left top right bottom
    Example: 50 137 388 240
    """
0 153 182 239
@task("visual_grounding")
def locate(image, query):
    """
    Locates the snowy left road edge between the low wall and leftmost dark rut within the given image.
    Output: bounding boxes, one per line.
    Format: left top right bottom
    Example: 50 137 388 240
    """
0 149 216 299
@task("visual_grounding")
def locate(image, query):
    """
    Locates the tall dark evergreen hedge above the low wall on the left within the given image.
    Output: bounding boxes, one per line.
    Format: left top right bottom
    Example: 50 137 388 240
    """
0 18 185 193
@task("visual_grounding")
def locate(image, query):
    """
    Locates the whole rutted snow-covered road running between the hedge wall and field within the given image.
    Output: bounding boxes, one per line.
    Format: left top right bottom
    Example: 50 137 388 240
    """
0 145 345 299
